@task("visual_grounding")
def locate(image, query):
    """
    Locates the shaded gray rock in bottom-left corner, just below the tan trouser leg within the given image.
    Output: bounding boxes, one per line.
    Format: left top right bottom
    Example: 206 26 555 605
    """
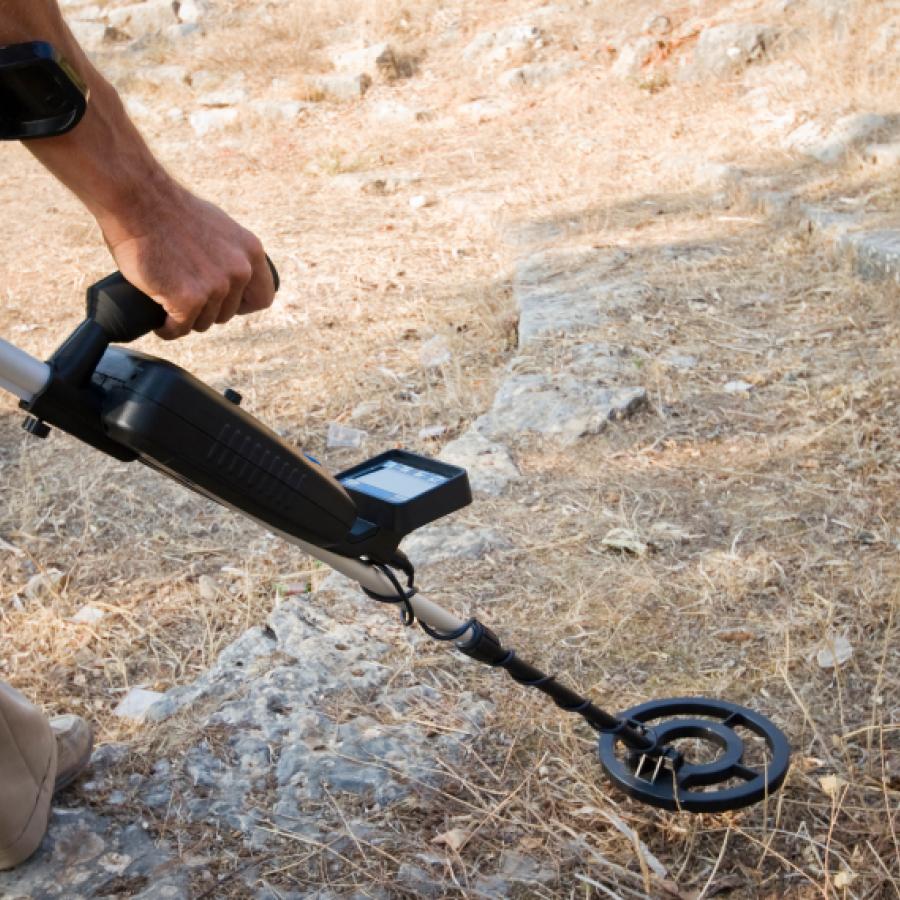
0 809 190 900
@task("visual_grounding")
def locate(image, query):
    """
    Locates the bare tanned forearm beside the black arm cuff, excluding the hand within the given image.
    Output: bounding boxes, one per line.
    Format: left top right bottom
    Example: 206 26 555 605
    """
0 0 180 243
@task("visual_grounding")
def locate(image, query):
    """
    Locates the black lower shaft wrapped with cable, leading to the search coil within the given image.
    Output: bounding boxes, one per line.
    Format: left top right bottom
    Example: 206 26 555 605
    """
456 619 656 753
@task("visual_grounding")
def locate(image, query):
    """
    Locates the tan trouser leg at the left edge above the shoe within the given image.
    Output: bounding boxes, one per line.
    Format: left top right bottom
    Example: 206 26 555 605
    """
0 681 56 869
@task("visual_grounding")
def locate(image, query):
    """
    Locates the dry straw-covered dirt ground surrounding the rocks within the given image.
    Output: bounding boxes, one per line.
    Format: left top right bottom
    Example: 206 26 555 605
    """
0 2 900 898
